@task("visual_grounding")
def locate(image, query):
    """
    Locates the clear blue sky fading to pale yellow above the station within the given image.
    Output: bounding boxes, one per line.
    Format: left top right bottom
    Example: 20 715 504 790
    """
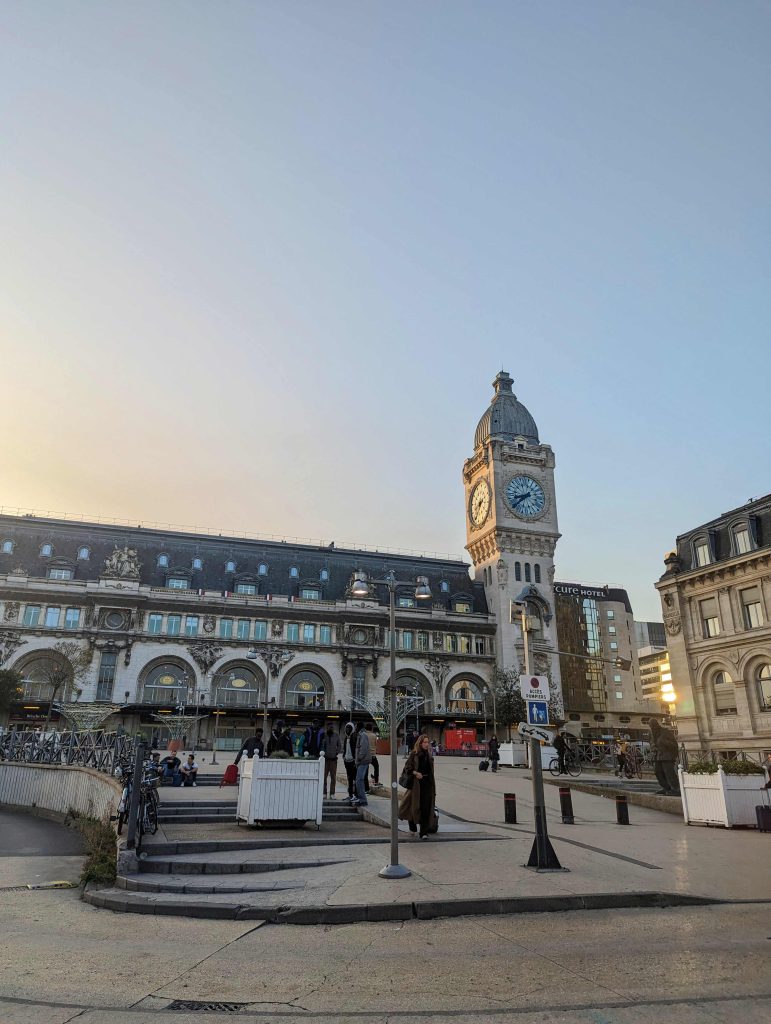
0 0 771 620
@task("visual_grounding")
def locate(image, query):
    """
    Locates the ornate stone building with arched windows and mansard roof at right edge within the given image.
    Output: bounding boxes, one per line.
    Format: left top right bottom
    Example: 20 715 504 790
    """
656 495 771 755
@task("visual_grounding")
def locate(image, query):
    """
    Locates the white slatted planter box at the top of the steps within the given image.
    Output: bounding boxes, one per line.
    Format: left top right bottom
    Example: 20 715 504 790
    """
235 755 324 827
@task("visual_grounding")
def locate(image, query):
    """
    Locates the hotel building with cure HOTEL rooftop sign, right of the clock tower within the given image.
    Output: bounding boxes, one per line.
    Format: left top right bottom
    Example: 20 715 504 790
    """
554 583 659 738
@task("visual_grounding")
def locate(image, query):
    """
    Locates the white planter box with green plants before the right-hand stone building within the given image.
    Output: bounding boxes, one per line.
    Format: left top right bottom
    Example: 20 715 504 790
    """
678 768 764 828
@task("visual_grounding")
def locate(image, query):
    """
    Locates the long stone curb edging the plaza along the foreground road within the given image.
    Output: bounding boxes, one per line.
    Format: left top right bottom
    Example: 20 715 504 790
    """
83 890 730 925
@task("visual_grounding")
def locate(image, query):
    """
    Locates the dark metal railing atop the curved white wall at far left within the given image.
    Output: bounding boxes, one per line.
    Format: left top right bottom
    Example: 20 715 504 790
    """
0 730 134 775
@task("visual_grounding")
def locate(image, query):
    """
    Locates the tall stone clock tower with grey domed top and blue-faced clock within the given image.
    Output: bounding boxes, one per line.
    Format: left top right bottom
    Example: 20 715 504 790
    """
463 371 562 711
